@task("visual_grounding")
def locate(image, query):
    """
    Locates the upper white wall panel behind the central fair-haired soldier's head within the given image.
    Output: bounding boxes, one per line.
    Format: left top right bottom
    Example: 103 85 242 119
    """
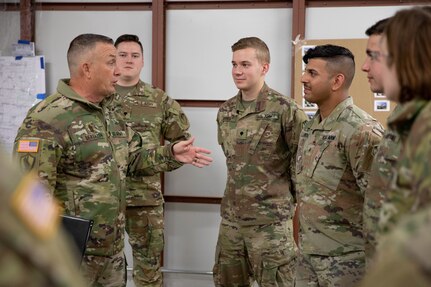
166 9 292 100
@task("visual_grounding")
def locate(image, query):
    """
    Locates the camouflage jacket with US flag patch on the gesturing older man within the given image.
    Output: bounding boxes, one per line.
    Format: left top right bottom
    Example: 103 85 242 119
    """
14 80 179 256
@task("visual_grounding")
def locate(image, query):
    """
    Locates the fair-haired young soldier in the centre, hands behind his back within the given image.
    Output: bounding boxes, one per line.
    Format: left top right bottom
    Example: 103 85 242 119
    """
214 37 307 287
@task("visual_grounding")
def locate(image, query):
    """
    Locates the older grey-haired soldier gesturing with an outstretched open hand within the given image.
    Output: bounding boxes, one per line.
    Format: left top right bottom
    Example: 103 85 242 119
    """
14 34 211 286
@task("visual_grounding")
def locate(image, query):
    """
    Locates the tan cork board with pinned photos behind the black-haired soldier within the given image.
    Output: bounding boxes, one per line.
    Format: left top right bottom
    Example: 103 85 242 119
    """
294 39 395 127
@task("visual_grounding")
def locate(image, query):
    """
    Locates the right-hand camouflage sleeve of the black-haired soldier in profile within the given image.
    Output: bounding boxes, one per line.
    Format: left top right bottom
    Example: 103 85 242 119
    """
348 121 383 195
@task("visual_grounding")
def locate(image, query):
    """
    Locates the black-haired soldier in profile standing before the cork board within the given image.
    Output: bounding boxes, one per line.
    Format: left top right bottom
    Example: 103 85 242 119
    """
296 45 383 286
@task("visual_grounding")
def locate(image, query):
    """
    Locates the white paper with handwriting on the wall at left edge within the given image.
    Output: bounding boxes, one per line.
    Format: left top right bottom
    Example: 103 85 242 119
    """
0 56 45 153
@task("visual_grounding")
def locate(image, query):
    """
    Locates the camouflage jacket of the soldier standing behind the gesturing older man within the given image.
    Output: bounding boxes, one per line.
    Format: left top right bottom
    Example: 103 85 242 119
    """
115 81 190 206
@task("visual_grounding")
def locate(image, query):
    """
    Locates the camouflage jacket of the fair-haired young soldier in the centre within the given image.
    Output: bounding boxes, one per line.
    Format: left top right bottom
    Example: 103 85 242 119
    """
217 84 307 225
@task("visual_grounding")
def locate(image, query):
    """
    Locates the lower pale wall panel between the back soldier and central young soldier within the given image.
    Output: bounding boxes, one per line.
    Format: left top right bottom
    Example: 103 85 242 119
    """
164 203 220 287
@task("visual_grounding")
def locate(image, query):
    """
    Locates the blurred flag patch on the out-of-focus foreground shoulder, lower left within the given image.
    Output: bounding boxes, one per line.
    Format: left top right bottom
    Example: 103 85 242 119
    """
11 174 60 239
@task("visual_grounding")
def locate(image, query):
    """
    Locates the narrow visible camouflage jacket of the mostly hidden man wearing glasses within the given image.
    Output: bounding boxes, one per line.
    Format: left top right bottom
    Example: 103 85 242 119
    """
363 105 401 264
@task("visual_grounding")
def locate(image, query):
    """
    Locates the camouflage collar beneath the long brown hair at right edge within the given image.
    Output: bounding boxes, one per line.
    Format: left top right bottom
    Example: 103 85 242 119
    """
388 99 429 135
